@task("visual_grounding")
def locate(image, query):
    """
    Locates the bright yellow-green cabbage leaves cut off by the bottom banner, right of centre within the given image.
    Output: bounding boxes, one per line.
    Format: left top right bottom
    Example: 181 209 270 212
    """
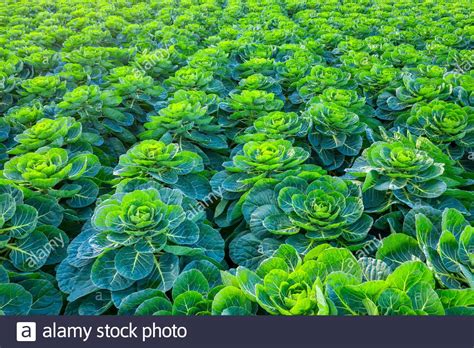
225 244 462 315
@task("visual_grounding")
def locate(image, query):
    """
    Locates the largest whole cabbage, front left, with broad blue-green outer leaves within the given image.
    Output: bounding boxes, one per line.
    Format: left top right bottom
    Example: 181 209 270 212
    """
58 180 224 308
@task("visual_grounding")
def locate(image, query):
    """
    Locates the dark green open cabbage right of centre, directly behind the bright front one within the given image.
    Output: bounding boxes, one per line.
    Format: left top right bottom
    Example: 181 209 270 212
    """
242 175 373 242
